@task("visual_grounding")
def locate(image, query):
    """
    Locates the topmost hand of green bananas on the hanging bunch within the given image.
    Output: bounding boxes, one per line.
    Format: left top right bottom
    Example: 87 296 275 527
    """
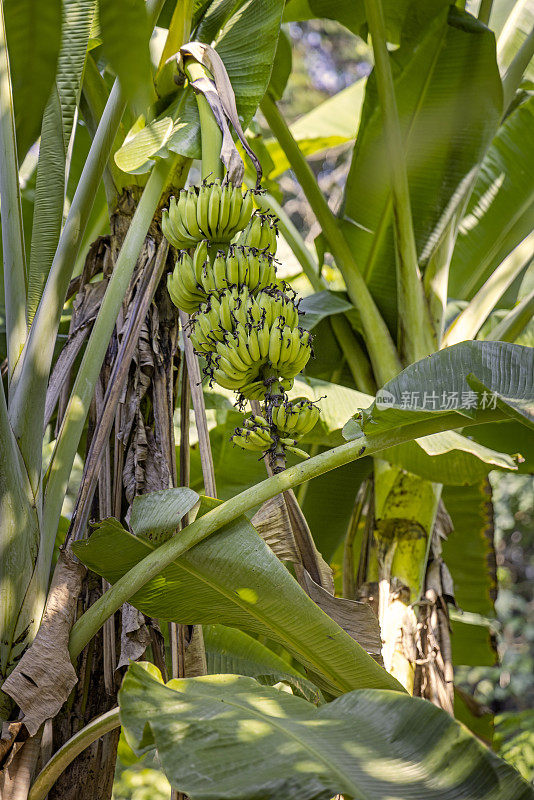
161 180 253 250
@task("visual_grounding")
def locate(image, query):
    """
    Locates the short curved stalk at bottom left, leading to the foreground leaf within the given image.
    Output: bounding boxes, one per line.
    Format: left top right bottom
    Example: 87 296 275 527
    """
28 708 121 800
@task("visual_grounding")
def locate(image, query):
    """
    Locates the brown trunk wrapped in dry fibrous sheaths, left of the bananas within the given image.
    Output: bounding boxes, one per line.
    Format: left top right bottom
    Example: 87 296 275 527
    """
49 187 178 800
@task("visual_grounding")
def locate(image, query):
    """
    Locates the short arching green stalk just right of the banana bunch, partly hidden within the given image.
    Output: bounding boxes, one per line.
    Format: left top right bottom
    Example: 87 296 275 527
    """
255 193 376 394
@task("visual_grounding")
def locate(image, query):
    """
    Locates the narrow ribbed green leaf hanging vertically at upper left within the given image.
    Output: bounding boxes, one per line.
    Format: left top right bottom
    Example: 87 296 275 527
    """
28 0 96 322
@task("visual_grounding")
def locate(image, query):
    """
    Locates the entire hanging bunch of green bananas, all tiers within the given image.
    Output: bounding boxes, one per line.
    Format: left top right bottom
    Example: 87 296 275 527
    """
162 175 319 460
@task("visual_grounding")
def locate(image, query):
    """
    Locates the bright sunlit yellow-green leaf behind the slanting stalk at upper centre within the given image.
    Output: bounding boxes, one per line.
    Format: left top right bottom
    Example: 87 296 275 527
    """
266 80 365 178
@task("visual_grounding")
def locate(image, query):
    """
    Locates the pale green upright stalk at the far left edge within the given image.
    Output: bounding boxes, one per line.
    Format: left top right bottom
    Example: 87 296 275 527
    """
0 0 27 381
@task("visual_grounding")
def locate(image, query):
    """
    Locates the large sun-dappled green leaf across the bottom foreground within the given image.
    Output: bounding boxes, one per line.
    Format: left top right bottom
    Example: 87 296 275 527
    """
119 664 534 800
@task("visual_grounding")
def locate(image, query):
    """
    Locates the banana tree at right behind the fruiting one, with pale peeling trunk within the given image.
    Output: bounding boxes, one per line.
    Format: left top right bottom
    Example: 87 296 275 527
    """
256 3 532 710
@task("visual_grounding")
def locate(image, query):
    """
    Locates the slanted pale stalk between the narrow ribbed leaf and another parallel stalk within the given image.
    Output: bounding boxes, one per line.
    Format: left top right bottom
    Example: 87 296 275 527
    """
9 0 163 486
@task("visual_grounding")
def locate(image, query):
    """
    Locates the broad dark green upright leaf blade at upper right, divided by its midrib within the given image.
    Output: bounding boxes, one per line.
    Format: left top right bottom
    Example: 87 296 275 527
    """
344 2 502 330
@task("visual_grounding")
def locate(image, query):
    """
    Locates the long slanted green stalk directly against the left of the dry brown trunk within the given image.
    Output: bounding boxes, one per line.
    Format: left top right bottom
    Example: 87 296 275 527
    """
43 156 189 552
